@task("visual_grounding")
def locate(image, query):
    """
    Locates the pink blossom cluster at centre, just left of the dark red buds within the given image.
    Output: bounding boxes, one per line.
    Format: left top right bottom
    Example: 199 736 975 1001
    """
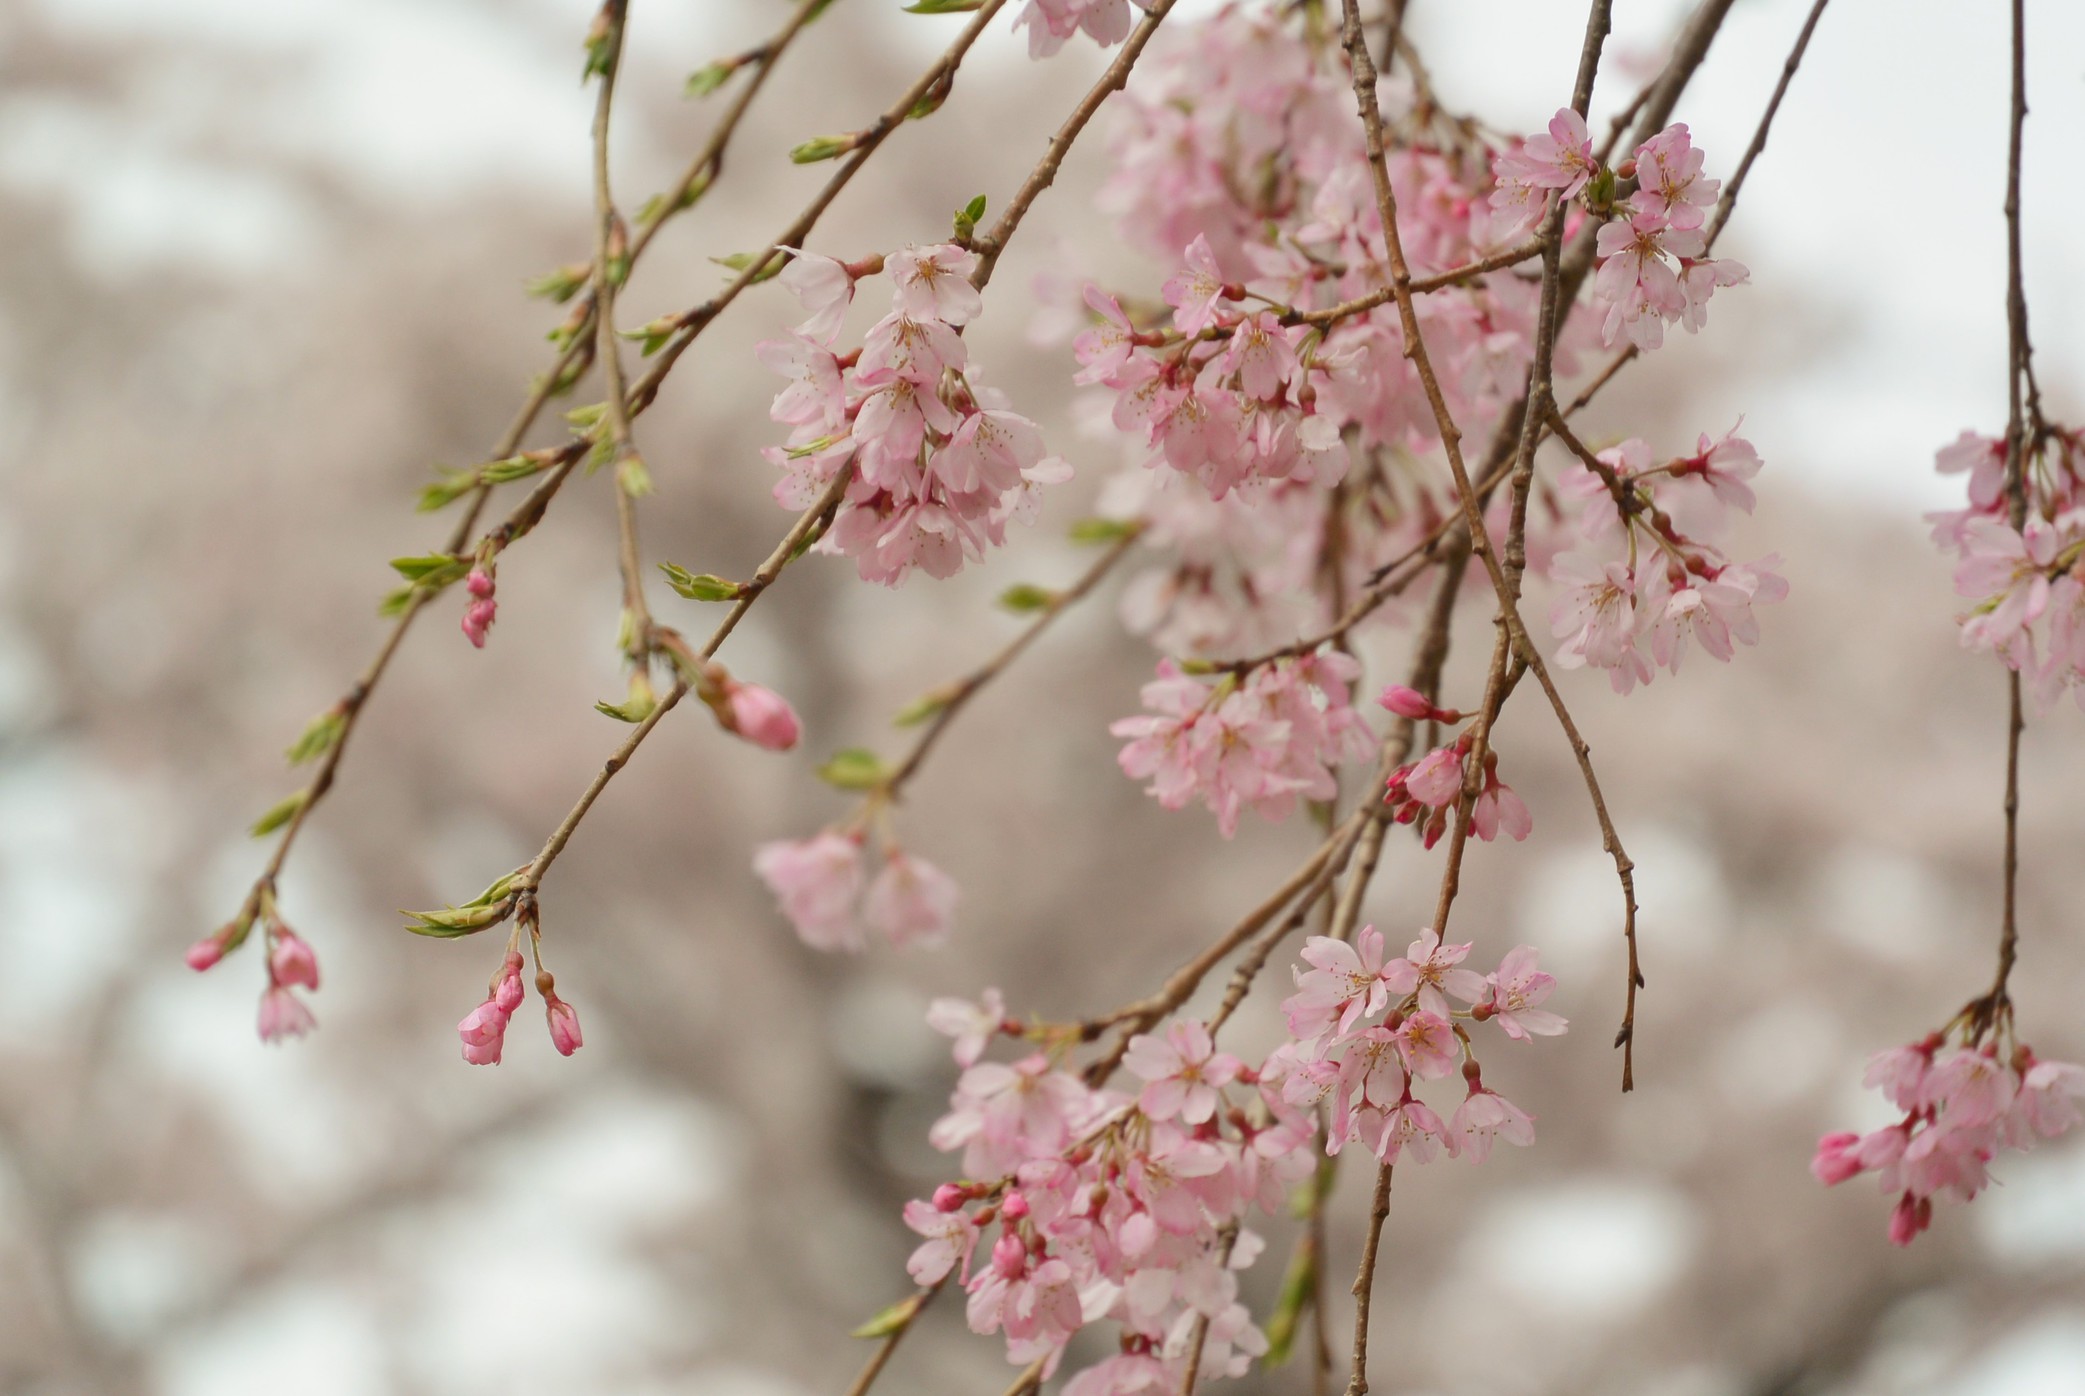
1109 650 1374 838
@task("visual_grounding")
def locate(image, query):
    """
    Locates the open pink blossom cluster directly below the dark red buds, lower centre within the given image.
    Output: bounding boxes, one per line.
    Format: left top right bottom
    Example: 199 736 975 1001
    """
1261 925 1566 1163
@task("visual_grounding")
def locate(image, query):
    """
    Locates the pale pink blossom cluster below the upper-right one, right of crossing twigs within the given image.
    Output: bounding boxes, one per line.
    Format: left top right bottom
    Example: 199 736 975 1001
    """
1549 429 1789 694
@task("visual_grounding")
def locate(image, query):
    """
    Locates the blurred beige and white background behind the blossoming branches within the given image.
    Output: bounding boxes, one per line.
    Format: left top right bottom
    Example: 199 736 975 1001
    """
0 0 2085 1396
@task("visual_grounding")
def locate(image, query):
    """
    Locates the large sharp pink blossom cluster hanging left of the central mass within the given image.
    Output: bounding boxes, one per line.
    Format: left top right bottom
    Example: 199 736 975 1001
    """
757 244 1072 585
